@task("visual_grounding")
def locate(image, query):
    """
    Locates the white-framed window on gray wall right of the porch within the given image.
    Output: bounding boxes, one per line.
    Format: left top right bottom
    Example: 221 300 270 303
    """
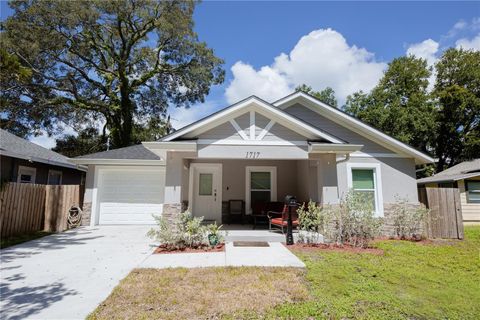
347 163 383 217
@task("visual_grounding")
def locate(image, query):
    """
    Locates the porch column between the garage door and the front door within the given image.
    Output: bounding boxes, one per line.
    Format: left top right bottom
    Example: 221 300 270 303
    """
163 151 183 218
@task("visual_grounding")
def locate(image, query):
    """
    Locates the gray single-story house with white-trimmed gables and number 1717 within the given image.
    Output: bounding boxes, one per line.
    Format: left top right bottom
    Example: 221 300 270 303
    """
72 92 433 229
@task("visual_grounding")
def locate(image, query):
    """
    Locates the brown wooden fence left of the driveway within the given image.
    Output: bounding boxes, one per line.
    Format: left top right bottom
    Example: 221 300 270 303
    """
0 183 83 239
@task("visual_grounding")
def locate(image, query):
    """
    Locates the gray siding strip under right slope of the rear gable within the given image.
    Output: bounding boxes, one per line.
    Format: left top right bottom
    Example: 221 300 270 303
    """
285 103 393 153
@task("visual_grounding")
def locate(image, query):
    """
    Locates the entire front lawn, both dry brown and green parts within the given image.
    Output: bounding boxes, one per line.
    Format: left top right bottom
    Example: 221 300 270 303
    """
90 226 480 319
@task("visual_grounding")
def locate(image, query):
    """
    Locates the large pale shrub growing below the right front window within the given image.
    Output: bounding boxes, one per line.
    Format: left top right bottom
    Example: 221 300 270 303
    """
328 191 383 248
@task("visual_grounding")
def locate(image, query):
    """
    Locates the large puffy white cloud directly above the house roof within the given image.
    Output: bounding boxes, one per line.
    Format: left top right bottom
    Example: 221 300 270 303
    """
225 29 386 104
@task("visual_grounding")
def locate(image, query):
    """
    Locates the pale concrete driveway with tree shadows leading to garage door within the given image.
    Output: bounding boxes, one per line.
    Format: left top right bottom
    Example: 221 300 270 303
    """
0 226 152 319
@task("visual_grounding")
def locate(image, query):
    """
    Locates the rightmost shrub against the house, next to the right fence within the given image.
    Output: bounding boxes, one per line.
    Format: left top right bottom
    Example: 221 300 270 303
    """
392 198 430 239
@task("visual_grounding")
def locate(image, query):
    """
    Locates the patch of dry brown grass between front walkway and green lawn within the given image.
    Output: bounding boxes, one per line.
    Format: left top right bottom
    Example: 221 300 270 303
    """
88 267 309 319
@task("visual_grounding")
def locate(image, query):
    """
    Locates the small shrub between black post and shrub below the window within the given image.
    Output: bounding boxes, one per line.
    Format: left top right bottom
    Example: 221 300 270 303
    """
297 200 331 243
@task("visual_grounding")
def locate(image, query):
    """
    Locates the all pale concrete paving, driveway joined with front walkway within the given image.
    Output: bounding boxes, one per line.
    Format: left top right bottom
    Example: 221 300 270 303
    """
0 226 305 319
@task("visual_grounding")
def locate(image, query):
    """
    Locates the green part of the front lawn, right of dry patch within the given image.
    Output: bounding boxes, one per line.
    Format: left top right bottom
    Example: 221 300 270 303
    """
269 226 480 319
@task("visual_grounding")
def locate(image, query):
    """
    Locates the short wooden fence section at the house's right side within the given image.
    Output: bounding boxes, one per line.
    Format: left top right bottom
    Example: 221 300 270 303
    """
418 187 463 239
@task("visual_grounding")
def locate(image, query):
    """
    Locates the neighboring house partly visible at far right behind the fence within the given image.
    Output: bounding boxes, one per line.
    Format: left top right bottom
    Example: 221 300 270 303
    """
417 159 480 224
